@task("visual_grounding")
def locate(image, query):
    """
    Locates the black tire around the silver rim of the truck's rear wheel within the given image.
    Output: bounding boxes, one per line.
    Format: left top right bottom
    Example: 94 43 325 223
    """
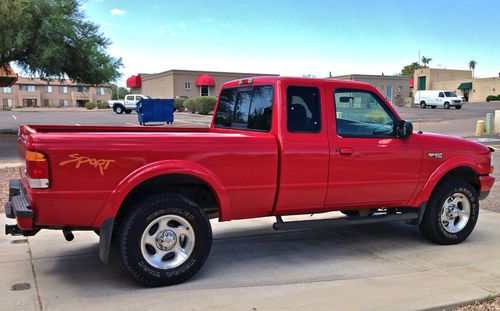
115 193 212 286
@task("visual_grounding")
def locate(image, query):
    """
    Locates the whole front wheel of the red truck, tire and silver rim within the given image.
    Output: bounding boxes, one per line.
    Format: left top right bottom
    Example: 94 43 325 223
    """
420 180 479 244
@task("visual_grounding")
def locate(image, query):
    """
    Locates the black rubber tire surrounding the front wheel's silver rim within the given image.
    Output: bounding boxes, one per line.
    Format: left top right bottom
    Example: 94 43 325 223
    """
420 179 479 245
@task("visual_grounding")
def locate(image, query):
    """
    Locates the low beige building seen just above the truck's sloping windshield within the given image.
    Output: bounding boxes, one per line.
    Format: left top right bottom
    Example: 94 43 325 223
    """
333 74 410 106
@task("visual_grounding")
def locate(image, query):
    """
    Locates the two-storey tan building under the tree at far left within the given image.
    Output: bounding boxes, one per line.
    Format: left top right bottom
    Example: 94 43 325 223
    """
0 77 111 109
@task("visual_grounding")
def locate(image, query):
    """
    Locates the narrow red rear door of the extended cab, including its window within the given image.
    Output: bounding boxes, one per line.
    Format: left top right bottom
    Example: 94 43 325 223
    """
275 82 329 214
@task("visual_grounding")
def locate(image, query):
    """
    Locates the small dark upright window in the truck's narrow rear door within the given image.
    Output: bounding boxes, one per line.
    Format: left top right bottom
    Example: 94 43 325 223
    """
286 86 321 133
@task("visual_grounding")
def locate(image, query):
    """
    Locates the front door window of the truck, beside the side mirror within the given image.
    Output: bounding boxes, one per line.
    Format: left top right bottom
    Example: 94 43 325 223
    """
334 89 395 138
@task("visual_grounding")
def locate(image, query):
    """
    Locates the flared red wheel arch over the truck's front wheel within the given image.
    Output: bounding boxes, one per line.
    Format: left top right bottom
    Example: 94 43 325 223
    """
410 158 480 206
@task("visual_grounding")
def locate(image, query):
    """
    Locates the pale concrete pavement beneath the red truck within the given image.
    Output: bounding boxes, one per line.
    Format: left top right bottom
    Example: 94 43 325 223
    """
0 211 500 310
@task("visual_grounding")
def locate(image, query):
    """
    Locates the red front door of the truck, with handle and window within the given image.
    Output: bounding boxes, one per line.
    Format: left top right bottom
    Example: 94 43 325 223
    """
326 88 422 208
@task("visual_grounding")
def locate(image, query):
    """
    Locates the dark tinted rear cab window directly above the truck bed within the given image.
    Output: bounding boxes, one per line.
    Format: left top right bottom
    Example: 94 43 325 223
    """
214 85 273 131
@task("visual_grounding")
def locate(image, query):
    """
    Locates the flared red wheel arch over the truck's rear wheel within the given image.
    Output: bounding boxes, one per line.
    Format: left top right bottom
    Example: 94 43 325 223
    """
92 160 231 228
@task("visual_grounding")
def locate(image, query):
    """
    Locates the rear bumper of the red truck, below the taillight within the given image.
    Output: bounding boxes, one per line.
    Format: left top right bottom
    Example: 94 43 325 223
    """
5 179 33 233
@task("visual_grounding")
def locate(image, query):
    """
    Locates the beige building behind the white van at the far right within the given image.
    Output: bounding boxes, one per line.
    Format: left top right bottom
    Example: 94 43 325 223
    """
414 68 500 102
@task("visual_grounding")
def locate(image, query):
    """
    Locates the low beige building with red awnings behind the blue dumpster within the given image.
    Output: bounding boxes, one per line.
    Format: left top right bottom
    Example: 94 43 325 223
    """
127 69 277 98
